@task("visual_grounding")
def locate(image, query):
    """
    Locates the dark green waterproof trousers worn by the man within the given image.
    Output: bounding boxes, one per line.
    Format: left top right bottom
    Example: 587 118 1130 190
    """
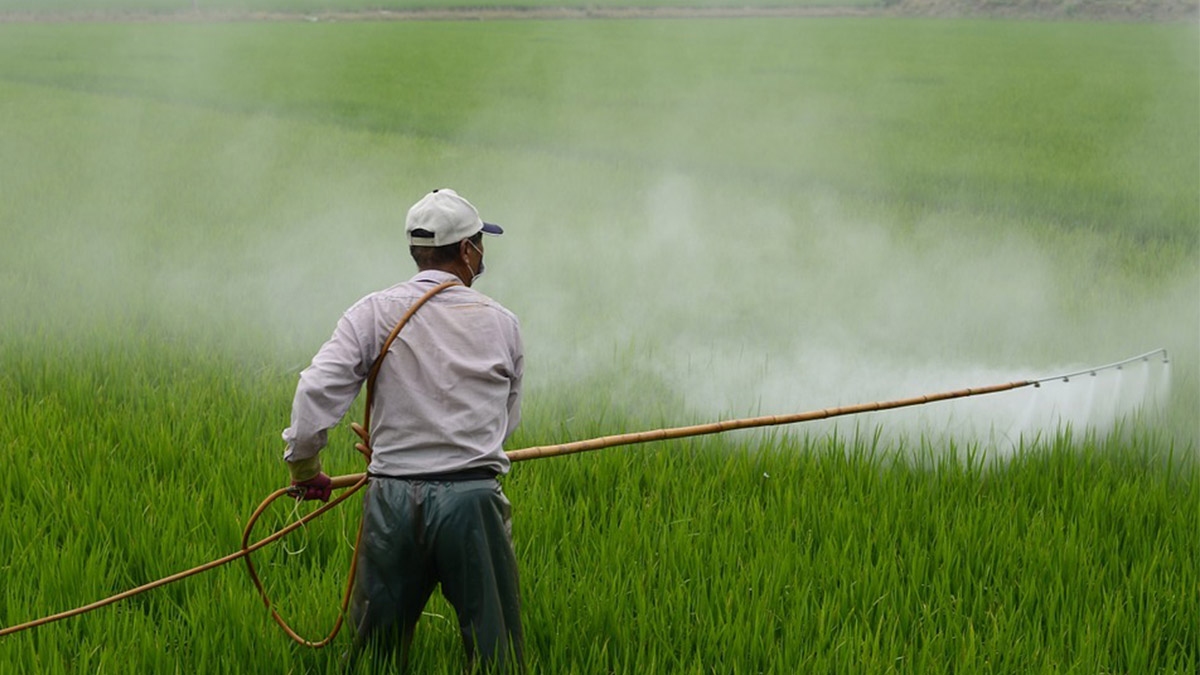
350 478 522 673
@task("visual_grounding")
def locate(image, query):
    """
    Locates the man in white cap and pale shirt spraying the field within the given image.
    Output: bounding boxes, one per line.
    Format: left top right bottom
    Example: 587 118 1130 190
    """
283 190 524 670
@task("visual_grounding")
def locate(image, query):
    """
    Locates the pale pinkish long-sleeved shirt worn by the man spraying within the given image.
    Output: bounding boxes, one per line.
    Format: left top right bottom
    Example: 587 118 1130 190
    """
283 270 524 476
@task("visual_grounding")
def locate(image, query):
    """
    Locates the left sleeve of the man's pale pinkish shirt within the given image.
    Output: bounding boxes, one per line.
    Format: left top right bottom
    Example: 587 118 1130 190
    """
283 307 371 464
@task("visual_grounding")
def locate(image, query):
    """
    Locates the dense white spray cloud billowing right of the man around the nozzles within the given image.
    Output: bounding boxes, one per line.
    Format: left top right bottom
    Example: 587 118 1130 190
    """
490 175 1194 452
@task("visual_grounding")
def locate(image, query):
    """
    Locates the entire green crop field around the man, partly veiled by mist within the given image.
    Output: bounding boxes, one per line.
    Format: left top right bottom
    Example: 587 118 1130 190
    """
0 18 1200 674
